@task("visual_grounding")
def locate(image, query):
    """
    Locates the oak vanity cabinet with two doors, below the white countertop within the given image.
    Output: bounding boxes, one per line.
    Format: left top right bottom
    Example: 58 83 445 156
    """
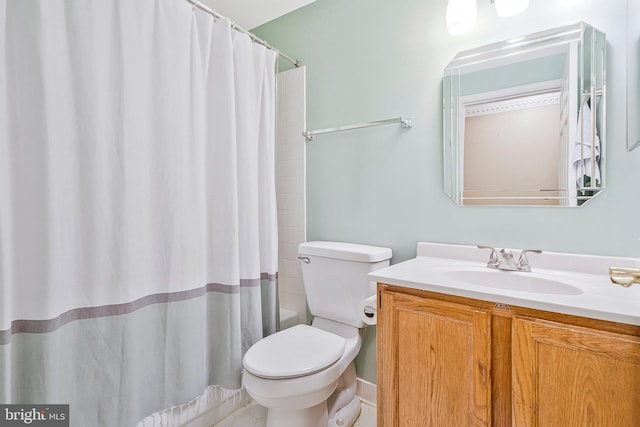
377 284 640 427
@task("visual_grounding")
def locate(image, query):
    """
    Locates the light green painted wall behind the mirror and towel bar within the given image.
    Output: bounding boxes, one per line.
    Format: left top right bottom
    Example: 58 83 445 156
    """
255 0 640 382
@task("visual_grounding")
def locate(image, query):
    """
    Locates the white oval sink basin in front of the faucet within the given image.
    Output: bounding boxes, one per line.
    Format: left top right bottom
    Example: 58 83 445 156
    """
446 270 582 295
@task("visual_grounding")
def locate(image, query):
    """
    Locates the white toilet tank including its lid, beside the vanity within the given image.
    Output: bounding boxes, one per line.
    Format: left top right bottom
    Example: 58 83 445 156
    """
298 242 391 328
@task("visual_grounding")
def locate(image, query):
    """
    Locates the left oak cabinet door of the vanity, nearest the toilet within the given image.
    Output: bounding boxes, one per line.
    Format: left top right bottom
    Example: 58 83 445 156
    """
377 291 491 427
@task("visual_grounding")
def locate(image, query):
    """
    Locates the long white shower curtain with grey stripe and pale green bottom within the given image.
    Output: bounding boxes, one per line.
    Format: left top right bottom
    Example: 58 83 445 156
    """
0 0 277 426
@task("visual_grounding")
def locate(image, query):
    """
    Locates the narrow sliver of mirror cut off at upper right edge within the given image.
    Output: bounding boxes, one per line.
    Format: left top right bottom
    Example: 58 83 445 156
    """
627 0 640 151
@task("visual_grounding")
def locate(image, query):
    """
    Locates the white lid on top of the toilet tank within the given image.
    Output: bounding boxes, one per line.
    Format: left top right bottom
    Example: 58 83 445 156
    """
298 241 391 262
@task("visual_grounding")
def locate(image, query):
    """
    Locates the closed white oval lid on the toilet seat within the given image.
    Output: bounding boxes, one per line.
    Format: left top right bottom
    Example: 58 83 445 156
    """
242 325 346 379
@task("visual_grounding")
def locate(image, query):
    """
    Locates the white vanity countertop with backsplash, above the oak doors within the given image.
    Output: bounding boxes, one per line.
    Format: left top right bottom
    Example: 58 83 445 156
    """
369 243 640 326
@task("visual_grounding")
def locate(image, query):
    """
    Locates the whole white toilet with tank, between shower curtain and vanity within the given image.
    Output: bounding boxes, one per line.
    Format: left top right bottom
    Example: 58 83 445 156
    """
242 242 391 427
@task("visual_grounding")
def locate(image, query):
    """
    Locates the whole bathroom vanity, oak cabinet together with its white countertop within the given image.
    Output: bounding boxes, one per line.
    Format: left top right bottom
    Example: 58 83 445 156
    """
370 243 640 427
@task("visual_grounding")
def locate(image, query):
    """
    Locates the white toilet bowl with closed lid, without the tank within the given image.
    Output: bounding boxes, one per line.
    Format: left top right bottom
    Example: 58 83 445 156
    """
242 319 362 427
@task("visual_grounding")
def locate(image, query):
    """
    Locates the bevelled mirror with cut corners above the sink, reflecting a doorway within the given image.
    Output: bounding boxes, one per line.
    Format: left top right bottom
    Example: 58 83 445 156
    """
443 23 606 206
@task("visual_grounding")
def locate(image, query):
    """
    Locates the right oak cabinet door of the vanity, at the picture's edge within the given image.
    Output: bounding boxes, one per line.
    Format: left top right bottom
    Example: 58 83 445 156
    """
512 318 640 427
